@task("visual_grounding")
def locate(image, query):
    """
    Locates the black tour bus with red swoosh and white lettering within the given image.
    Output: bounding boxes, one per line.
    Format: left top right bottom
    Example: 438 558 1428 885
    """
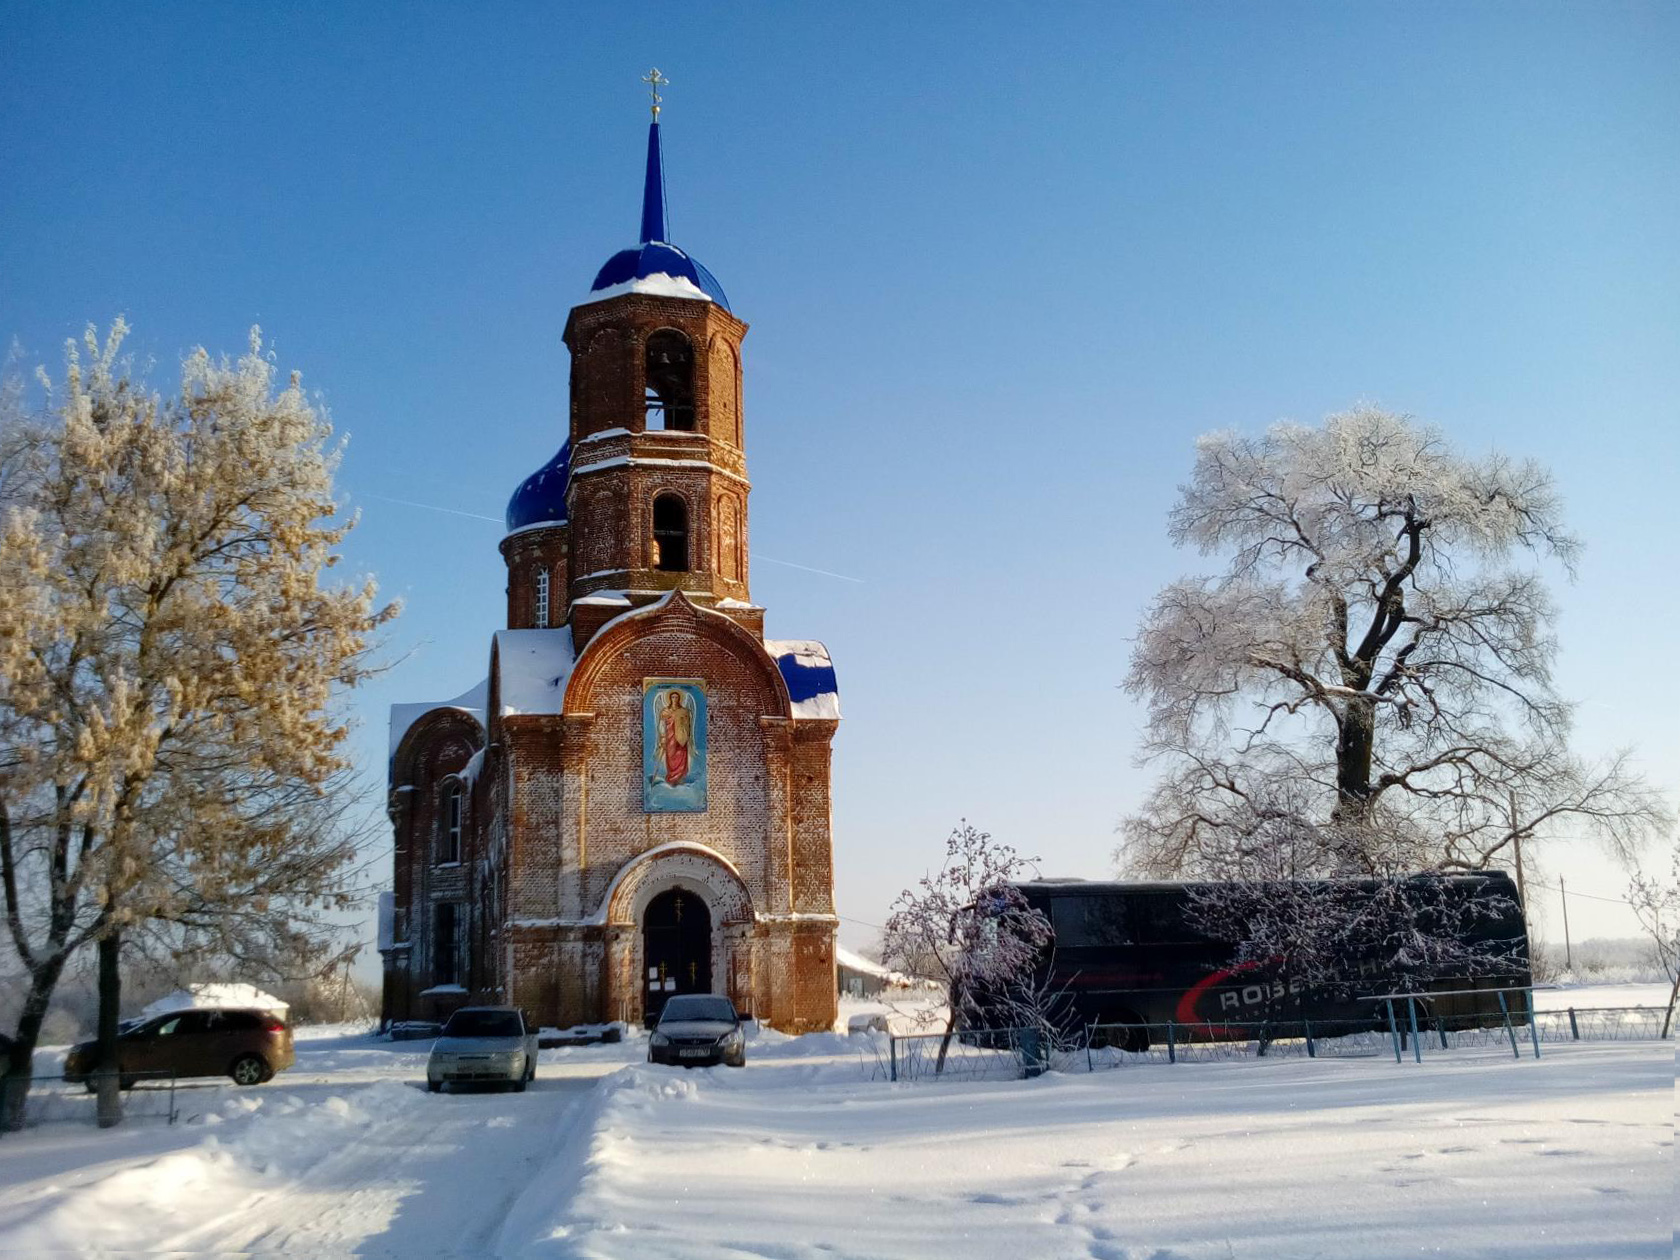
969 872 1532 1050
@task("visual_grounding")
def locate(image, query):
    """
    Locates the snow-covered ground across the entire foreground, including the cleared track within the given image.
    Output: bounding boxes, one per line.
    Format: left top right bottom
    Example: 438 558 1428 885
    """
0 1014 1675 1260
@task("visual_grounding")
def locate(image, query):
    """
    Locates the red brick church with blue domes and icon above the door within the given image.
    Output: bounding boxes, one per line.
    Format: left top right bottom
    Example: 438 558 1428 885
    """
380 89 840 1032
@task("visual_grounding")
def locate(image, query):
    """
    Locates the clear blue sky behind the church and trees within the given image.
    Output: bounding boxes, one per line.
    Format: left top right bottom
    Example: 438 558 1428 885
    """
0 3 1680 944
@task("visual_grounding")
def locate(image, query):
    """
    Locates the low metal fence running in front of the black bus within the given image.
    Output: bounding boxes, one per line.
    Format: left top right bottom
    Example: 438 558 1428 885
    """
867 1003 1667 1082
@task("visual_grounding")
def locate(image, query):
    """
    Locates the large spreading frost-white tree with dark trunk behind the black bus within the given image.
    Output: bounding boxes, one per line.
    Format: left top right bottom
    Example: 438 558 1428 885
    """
1117 407 1667 879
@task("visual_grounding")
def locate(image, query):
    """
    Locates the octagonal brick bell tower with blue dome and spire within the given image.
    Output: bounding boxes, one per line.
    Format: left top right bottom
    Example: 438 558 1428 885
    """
556 84 764 650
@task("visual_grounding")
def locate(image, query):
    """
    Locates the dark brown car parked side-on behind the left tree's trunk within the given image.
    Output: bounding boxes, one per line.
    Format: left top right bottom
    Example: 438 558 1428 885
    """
64 1010 297 1089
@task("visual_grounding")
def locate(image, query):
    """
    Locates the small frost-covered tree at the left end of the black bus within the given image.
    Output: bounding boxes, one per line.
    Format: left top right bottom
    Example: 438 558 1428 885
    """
880 822 1052 1070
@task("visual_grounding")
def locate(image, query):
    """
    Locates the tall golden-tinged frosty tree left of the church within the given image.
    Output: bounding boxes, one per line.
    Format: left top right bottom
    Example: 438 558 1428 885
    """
0 319 395 1124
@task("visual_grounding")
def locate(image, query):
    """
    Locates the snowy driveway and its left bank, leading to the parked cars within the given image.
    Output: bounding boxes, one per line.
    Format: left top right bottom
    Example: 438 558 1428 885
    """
0 1037 635 1260
